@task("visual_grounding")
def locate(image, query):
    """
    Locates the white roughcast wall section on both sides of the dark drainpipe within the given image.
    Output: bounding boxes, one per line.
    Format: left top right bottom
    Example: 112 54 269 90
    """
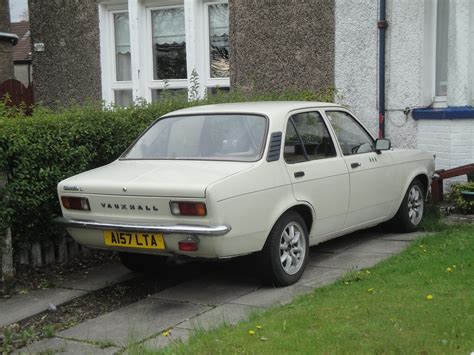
335 0 424 148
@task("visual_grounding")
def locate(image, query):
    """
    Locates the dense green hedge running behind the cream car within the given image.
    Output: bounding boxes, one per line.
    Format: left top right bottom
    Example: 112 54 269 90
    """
0 90 333 250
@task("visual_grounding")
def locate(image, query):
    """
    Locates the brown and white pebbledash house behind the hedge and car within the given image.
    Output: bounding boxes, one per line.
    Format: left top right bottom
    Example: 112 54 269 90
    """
29 0 474 177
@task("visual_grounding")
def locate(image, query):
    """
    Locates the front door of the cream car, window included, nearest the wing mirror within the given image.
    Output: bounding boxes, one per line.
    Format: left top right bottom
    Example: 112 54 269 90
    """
325 110 397 228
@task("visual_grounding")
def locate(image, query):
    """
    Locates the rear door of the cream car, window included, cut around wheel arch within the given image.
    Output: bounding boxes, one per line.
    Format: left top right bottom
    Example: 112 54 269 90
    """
283 110 349 238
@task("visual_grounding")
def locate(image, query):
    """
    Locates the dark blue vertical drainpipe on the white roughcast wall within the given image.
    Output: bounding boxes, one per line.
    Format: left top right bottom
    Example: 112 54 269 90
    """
377 0 388 138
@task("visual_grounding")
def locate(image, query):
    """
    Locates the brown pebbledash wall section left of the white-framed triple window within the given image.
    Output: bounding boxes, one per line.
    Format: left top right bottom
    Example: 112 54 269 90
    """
29 0 101 105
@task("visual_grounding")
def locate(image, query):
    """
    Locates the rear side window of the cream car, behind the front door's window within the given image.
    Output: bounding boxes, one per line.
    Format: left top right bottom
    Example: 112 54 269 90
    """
284 112 336 163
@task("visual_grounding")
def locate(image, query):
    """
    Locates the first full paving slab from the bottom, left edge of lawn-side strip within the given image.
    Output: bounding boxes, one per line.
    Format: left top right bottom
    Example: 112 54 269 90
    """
58 298 210 346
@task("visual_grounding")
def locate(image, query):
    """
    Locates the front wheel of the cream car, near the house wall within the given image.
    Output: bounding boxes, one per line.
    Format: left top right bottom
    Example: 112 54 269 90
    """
390 179 425 233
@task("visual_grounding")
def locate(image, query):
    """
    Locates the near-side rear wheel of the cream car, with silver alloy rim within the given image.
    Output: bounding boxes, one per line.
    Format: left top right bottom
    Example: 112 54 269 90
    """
261 211 309 287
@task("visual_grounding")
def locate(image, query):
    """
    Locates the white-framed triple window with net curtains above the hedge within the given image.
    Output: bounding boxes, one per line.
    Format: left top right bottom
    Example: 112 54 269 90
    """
99 0 229 105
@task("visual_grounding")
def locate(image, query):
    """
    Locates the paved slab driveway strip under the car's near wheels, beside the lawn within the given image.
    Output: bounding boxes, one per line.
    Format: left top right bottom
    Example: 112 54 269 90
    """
12 230 422 354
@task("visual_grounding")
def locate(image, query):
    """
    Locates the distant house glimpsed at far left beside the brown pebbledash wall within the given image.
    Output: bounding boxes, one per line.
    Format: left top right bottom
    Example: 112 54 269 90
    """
11 21 32 87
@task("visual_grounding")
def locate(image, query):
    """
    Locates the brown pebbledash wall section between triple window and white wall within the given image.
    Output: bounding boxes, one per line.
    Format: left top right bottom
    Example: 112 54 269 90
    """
229 0 335 91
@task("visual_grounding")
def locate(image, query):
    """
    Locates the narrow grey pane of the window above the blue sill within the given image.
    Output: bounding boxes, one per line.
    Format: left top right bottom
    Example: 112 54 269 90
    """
435 0 449 96
